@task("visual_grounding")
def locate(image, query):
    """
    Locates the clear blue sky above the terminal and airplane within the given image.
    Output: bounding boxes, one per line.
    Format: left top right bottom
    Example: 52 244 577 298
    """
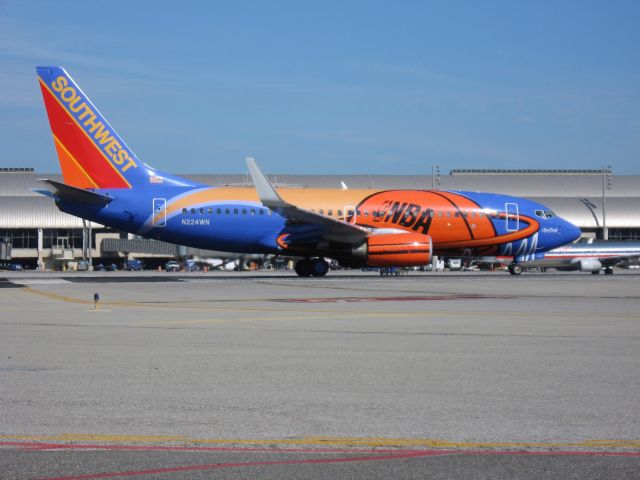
0 0 640 175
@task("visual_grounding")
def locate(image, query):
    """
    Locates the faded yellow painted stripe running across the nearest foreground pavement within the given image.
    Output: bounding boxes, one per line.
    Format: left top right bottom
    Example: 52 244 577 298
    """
0 433 640 454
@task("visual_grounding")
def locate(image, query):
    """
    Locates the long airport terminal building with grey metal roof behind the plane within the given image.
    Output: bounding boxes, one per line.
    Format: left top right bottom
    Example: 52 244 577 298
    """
0 168 640 269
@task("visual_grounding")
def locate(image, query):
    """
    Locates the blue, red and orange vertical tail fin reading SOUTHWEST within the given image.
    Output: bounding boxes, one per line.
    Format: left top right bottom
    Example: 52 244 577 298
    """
36 67 197 188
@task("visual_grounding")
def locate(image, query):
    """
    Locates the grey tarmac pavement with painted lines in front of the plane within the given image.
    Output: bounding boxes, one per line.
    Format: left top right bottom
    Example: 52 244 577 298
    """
0 271 640 479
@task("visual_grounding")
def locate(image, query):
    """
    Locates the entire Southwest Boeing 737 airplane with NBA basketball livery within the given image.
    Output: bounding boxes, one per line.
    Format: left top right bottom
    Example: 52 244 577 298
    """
37 67 580 277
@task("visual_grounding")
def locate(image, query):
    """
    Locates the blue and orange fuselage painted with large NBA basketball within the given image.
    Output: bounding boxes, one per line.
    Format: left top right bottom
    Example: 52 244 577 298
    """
58 186 576 259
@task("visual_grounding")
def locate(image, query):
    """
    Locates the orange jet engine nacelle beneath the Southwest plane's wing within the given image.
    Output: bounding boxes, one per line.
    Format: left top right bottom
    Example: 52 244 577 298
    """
362 233 433 267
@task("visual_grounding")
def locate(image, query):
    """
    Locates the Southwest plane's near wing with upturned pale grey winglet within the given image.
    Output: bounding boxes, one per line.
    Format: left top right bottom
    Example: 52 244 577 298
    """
246 157 371 243
